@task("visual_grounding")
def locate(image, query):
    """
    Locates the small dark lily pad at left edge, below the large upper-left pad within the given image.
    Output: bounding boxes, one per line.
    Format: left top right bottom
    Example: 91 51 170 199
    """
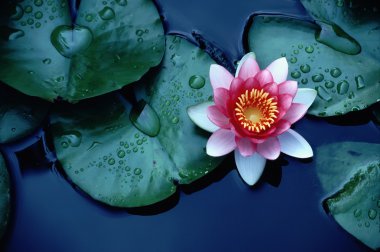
0 84 49 143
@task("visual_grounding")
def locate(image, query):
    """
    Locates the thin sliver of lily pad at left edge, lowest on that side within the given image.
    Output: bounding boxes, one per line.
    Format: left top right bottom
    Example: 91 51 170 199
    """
0 154 10 237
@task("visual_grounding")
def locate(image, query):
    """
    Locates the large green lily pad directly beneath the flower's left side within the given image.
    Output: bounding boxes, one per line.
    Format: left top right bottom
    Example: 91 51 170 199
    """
51 36 220 207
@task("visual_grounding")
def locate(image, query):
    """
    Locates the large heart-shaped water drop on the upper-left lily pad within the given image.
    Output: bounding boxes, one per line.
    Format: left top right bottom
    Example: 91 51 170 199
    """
50 25 93 58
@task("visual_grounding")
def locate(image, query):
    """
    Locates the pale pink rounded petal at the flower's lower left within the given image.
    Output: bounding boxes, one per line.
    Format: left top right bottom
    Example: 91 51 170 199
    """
206 129 236 157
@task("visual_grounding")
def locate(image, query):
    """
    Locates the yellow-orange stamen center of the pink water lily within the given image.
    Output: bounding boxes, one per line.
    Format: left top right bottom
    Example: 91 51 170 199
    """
235 88 278 133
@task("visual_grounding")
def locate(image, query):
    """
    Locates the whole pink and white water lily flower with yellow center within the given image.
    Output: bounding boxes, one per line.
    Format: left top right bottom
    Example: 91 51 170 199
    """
188 53 317 185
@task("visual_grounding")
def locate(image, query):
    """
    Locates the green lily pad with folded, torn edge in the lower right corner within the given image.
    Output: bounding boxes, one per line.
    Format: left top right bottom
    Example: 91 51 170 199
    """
317 142 380 249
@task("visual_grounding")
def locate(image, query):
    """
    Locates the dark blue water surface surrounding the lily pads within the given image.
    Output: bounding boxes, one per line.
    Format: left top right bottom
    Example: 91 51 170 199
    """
0 0 380 252
